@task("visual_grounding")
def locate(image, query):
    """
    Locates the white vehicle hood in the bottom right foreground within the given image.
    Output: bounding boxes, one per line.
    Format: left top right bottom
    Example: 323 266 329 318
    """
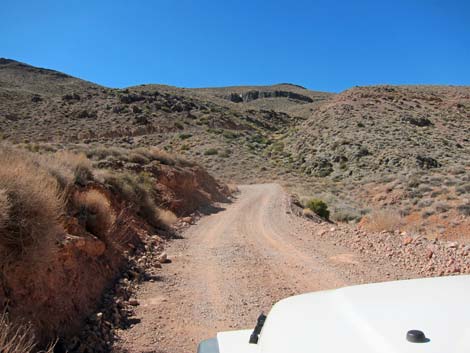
218 276 470 353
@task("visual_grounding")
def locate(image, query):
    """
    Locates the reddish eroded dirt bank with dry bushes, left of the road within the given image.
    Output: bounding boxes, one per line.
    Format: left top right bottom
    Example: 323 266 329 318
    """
0 146 228 352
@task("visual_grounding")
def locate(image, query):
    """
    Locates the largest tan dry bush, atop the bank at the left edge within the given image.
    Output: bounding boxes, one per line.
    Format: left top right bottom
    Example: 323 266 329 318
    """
0 148 64 261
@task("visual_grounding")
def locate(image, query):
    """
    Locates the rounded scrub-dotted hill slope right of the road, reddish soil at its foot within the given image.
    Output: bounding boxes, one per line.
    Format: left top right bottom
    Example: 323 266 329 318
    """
284 86 470 237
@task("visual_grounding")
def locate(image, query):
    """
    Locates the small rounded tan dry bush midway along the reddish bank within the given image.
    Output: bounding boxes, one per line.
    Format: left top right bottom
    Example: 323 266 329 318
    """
74 190 116 240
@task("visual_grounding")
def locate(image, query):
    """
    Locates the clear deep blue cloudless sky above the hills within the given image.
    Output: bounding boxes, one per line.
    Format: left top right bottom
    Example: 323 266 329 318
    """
0 0 470 91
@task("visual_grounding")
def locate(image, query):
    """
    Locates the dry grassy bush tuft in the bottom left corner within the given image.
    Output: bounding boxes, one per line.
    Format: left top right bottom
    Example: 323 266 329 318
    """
0 313 54 353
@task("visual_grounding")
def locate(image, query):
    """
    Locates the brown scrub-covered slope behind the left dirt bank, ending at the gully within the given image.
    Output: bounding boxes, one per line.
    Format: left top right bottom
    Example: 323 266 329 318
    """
0 59 320 181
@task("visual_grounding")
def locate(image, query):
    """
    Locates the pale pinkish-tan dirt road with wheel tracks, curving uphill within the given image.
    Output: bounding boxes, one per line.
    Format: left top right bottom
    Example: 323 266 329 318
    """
115 184 402 353
